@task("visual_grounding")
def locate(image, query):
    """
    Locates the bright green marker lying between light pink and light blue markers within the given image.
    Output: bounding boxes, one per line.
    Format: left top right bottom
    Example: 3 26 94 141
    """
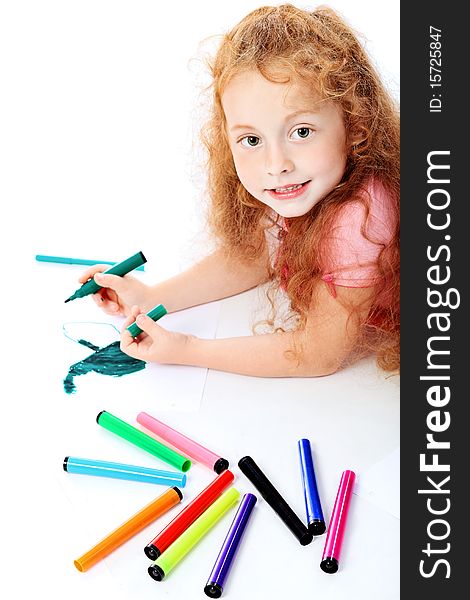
96 410 191 472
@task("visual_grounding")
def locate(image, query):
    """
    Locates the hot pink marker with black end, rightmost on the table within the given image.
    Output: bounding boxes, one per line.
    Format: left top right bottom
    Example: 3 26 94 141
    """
320 470 356 573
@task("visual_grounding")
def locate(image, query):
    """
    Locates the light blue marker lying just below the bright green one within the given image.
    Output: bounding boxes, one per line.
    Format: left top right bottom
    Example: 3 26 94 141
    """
64 456 186 487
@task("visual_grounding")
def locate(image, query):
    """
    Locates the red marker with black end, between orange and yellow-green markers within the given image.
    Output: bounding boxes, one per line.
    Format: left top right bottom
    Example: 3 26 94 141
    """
144 469 235 560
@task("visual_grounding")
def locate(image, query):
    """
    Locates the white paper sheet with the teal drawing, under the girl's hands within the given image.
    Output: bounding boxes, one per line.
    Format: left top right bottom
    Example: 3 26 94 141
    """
36 263 220 412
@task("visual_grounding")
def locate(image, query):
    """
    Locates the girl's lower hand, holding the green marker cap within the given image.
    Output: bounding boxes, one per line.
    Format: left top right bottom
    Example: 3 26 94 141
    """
121 306 196 364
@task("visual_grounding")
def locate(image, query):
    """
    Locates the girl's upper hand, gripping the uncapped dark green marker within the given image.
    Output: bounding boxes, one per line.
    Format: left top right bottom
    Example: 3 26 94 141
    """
79 265 151 316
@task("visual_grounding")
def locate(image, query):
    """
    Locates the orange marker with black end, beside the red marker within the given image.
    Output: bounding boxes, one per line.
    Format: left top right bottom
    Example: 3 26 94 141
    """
74 487 183 572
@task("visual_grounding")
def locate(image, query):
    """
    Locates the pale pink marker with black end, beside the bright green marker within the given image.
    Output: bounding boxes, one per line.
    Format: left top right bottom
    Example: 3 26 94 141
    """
137 412 229 474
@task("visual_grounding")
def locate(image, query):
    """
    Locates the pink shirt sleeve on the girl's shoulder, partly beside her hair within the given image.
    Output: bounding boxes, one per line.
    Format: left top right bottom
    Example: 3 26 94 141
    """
322 184 396 296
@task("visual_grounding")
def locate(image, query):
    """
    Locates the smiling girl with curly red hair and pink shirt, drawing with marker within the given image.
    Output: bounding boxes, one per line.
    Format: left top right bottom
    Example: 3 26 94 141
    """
80 4 399 377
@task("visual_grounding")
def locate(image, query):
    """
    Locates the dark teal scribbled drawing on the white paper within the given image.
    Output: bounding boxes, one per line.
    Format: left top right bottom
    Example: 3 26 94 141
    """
64 339 146 394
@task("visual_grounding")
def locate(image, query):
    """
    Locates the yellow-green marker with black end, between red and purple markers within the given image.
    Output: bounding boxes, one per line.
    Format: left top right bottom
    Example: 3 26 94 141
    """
148 488 240 581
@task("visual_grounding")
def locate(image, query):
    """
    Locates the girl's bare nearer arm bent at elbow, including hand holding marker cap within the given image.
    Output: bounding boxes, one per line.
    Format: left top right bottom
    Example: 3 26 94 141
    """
121 282 371 377
